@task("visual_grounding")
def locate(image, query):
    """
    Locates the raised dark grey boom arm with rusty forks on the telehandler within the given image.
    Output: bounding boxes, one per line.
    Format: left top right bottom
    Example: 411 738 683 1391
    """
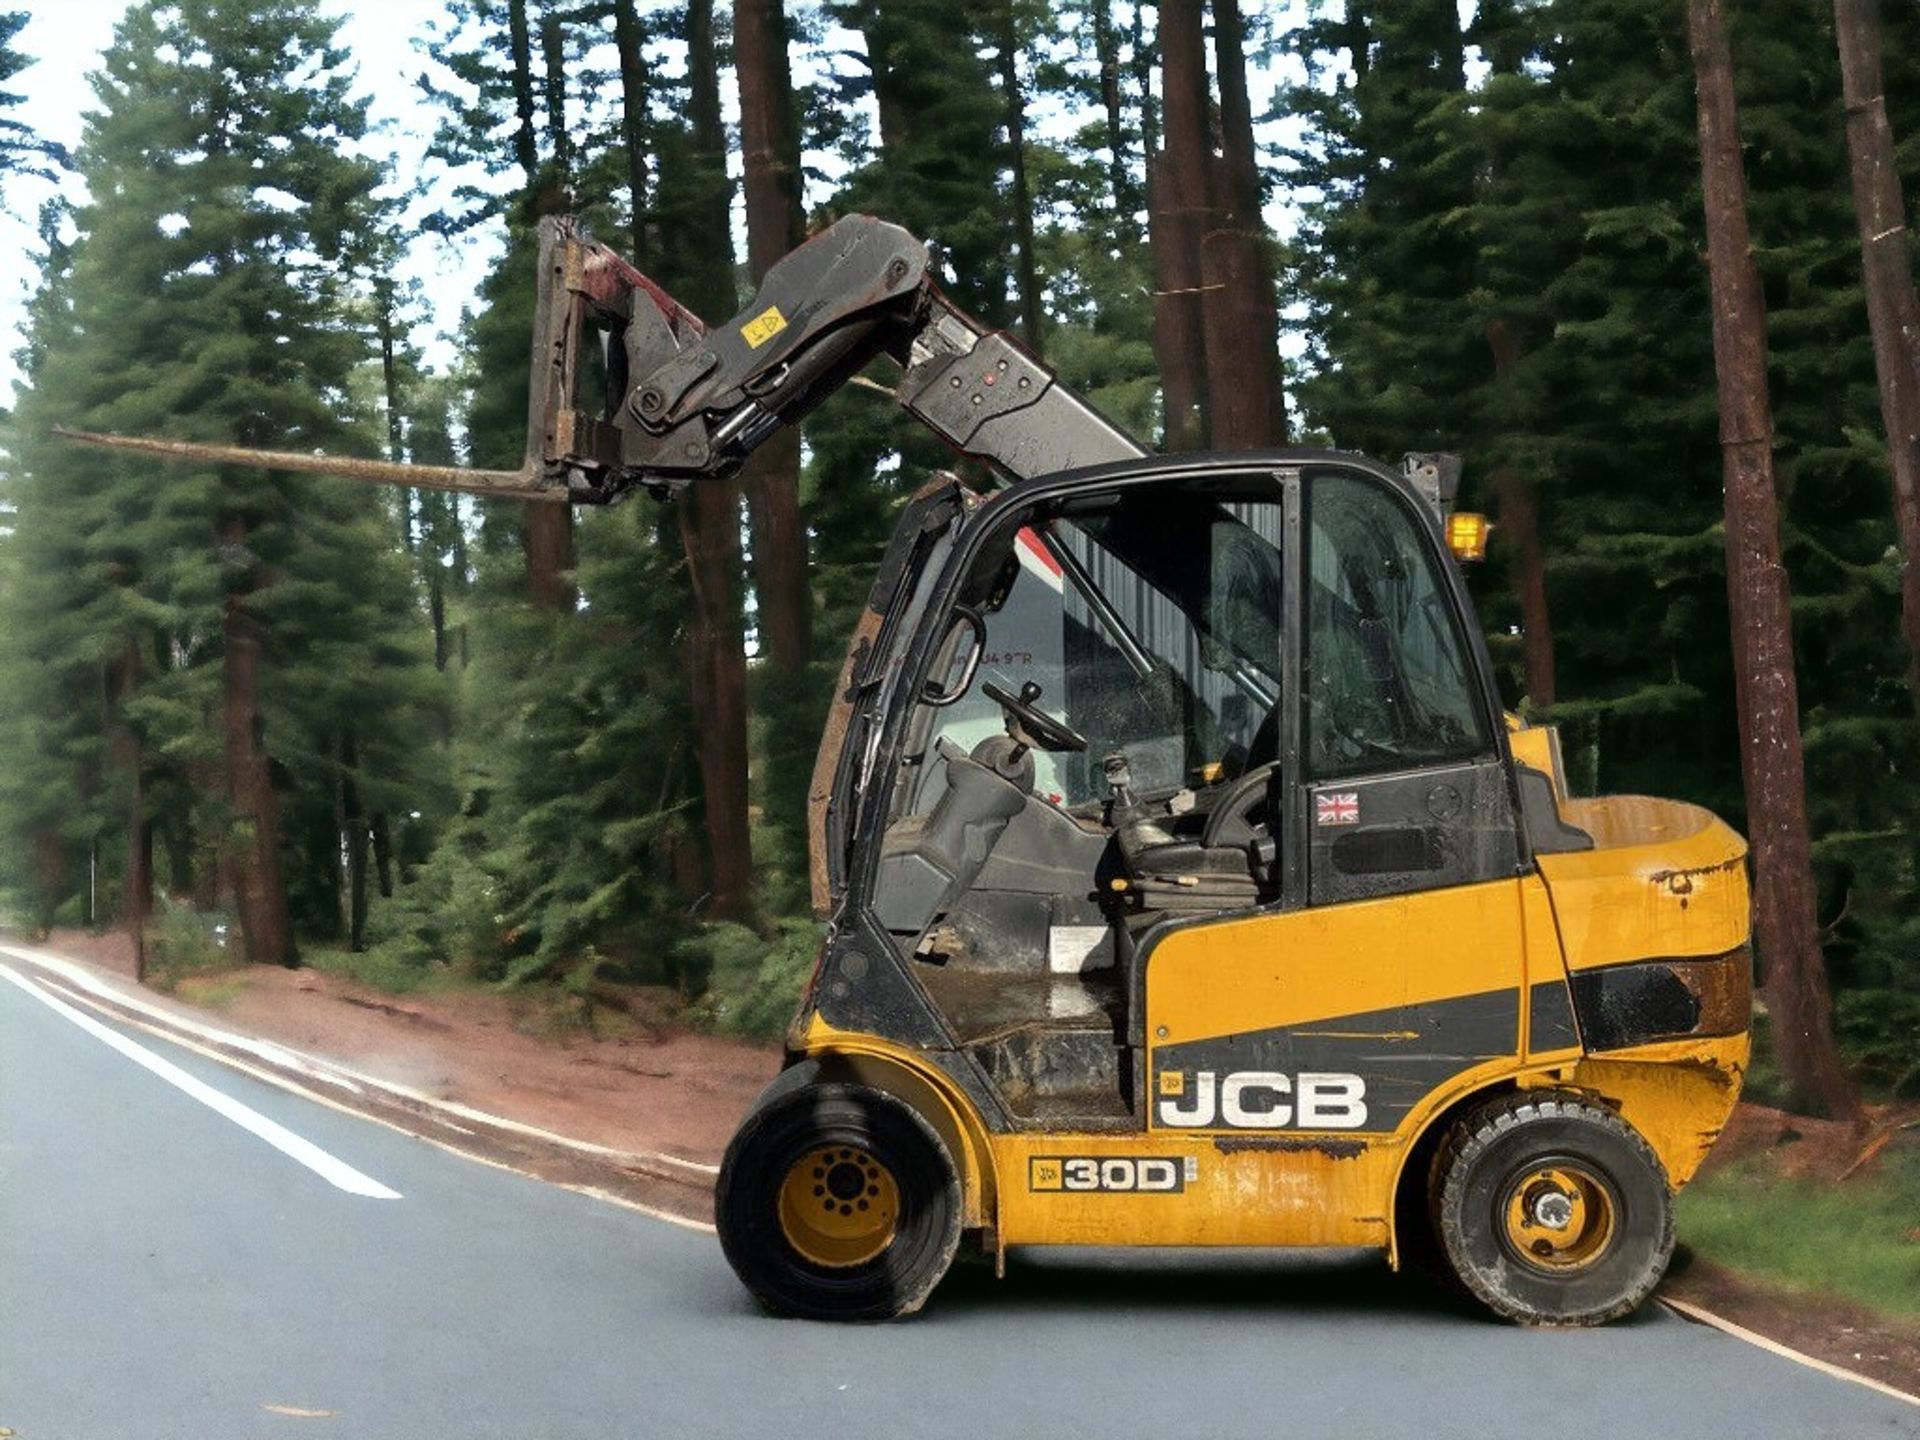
52 215 1146 505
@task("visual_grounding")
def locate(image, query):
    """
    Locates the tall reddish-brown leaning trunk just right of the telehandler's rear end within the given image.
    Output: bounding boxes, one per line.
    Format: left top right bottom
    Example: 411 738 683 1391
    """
1688 0 1860 1121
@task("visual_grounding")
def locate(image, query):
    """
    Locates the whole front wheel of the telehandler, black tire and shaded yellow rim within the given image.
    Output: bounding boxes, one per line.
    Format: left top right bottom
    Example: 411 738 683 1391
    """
714 1085 960 1321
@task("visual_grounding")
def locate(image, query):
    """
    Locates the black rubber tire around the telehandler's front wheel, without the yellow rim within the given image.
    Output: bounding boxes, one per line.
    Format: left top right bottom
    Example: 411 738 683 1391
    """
714 1085 960 1321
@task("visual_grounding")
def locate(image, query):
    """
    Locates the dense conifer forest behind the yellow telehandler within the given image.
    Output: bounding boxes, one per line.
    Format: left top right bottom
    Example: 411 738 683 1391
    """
0 0 1920 1110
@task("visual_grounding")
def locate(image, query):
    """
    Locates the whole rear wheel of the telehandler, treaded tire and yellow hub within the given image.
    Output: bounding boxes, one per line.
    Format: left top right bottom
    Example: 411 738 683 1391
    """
1434 1094 1674 1325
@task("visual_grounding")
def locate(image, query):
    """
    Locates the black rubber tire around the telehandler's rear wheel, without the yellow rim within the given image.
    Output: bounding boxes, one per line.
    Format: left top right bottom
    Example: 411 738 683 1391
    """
1432 1091 1674 1325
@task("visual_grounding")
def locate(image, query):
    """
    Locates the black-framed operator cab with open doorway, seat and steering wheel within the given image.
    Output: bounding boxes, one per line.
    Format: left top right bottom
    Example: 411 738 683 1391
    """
870 457 1517 1125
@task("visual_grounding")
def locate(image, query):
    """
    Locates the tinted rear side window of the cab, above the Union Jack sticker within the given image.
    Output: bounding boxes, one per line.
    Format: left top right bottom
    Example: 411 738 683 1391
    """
1302 472 1492 778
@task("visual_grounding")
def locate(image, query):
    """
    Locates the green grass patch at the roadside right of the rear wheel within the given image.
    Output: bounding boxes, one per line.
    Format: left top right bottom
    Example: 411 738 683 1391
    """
1680 1133 1920 1319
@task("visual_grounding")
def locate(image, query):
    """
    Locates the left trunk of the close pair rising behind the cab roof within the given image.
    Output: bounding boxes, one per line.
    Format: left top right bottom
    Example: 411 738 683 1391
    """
1146 0 1210 449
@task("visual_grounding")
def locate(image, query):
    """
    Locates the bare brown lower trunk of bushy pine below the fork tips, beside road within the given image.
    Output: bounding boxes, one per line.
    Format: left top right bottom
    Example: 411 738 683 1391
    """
221 520 300 966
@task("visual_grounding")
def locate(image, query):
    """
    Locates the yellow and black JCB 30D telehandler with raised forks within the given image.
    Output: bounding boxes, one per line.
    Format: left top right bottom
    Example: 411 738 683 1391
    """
67 217 1751 1325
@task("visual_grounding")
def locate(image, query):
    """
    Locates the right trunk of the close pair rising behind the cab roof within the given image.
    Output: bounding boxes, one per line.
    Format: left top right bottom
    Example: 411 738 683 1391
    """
1200 0 1286 449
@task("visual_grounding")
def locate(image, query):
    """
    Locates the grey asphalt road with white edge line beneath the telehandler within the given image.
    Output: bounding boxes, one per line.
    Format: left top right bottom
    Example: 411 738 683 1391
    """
0 975 1920 1440
